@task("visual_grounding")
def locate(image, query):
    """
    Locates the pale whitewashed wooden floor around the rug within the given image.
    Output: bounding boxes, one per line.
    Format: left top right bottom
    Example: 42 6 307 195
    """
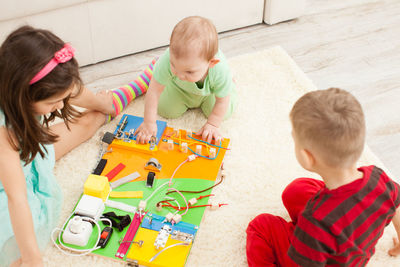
82 0 400 181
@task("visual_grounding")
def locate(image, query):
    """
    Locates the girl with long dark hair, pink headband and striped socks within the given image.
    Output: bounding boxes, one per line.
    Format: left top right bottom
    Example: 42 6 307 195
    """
0 26 156 266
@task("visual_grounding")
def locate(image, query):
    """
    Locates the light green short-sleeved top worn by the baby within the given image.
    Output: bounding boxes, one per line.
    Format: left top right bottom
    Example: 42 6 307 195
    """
153 48 235 97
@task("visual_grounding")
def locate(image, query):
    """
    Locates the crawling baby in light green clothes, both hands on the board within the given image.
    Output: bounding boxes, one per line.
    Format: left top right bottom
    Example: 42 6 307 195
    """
136 17 236 143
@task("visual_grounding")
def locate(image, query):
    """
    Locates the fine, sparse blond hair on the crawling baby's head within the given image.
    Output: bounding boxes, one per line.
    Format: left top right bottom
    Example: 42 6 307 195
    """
169 16 218 61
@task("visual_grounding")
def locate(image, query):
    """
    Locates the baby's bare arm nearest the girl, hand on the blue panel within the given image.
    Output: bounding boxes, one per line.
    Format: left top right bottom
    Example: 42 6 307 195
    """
135 79 165 143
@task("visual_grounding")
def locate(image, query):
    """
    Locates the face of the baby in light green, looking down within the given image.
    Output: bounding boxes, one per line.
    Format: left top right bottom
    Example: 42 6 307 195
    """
170 53 210 82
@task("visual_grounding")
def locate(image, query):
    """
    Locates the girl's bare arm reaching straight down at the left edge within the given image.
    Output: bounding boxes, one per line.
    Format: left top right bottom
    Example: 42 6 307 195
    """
0 127 43 266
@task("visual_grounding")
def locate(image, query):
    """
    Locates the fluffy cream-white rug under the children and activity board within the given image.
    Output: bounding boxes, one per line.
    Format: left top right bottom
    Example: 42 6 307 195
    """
45 47 400 266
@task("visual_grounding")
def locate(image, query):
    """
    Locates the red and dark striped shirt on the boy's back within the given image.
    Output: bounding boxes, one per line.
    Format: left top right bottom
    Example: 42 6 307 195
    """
288 166 400 267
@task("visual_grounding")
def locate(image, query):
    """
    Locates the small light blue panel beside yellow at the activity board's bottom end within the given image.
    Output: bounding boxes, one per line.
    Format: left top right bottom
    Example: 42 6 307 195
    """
142 214 198 235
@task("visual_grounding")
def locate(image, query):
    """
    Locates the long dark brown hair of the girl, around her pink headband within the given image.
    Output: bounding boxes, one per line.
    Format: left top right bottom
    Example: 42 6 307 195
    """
0 26 83 164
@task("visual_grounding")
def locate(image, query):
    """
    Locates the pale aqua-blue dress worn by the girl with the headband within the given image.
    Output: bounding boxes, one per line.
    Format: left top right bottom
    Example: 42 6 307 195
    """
0 110 62 266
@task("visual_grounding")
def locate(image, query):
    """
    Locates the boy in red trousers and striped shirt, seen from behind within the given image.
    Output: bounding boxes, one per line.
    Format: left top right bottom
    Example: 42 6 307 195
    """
246 88 400 267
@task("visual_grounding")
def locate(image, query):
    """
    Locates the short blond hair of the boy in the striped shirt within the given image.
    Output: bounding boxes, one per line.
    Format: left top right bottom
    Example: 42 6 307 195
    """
290 88 365 167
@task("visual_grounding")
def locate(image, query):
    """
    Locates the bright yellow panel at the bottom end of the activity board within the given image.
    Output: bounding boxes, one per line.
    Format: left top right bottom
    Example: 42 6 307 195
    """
126 227 192 267
